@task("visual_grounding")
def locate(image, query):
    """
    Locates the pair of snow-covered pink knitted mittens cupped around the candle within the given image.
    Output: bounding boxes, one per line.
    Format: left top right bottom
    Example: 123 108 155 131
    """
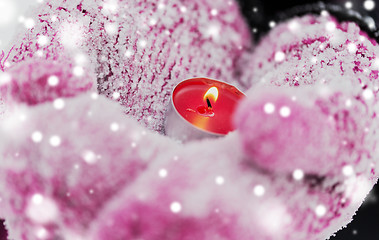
0 0 379 240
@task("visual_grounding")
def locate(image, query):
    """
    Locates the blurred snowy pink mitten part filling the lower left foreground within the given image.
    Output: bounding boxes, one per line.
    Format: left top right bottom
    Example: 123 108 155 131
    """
0 94 175 239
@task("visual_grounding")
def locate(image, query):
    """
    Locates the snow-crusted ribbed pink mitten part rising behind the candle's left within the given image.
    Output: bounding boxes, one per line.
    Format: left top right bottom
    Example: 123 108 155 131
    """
5 0 251 131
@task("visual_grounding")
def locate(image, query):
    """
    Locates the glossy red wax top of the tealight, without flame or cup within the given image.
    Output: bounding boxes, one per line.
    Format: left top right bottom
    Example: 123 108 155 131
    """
172 78 245 134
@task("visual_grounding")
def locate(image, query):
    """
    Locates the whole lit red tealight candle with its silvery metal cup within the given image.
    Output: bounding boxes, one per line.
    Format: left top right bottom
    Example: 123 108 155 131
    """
165 78 245 141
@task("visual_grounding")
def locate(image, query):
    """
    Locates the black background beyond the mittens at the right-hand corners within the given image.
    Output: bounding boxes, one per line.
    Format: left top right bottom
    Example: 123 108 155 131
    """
0 0 379 240
